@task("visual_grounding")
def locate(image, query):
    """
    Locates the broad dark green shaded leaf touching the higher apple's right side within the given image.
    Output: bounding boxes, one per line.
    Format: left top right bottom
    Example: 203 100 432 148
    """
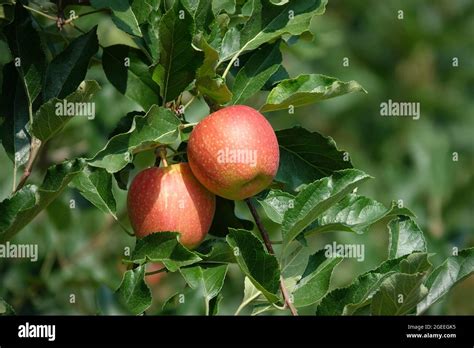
276 127 352 191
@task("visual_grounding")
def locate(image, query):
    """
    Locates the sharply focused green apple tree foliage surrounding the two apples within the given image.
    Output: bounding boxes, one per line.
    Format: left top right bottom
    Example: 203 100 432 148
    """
0 0 474 315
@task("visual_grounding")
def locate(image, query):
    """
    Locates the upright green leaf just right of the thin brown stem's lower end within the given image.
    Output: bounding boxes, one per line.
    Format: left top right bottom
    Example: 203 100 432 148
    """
293 249 342 307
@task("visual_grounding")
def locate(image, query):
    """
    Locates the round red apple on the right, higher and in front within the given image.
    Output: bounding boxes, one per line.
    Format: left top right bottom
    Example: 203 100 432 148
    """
187 105 280 200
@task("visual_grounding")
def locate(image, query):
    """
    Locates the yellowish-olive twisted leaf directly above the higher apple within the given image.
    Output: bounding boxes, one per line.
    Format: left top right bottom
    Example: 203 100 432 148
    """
196 37 232 104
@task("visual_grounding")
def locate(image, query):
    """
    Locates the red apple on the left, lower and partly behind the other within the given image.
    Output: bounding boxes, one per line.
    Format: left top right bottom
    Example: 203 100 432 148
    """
127 163 216 248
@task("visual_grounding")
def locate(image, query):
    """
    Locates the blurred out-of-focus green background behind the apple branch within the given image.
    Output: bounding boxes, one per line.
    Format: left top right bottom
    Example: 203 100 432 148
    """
0 0 474 314
